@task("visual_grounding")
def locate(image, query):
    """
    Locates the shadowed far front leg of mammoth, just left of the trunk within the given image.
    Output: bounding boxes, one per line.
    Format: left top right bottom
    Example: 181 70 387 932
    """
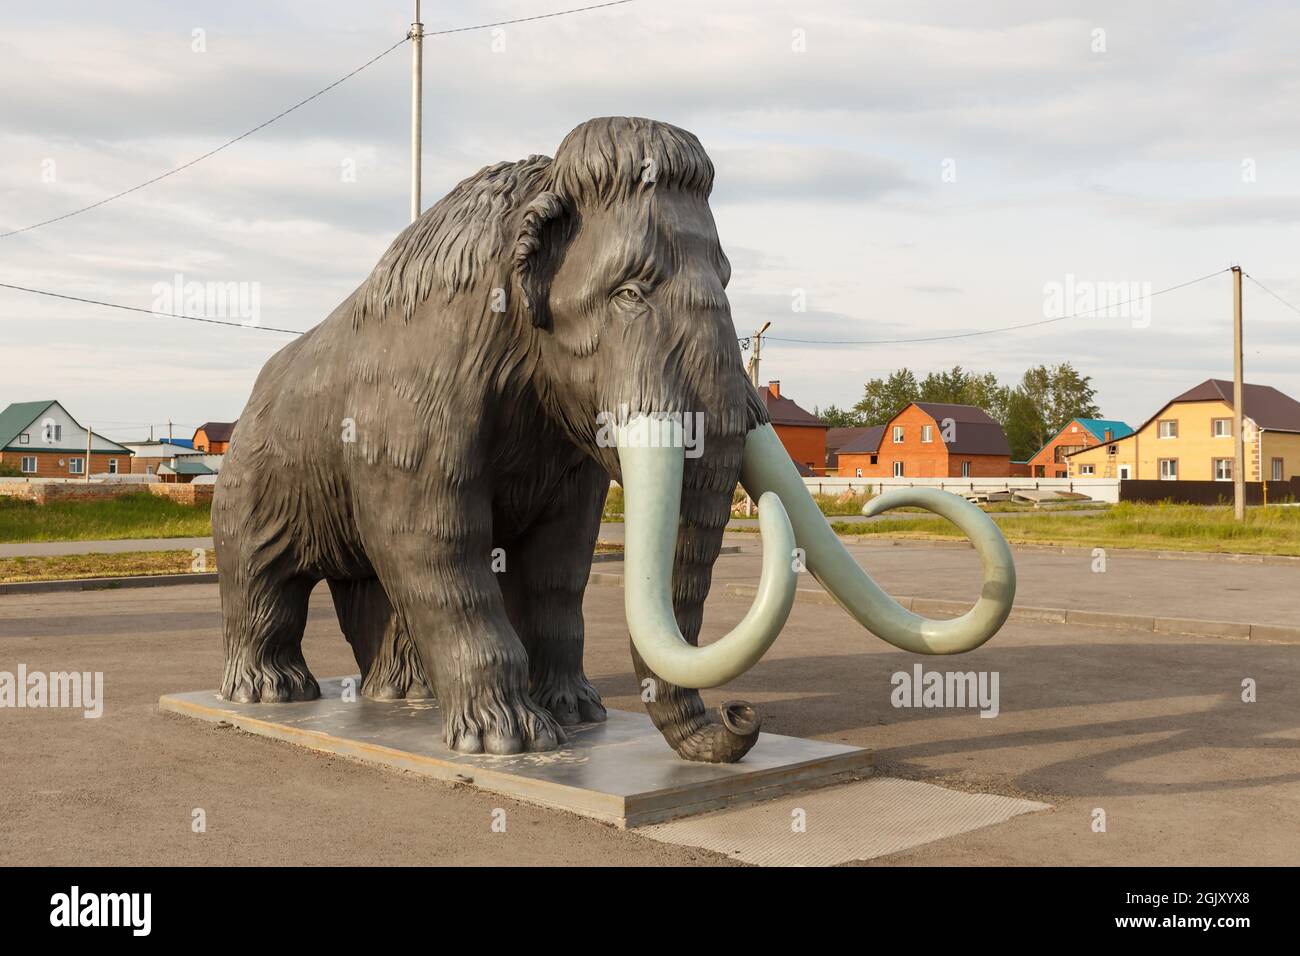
498 458 610 726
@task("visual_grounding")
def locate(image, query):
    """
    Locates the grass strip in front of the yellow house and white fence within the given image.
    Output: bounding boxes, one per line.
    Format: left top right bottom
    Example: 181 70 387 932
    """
831 502 1300 555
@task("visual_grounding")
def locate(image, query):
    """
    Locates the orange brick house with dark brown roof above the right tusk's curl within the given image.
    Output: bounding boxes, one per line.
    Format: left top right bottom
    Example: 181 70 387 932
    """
839 402 1011 477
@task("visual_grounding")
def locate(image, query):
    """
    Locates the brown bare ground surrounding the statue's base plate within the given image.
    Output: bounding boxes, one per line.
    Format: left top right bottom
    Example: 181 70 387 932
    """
0 574 1300 865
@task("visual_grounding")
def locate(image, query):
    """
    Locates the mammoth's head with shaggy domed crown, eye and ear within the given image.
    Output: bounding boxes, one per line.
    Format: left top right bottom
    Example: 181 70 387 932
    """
511 117 757 475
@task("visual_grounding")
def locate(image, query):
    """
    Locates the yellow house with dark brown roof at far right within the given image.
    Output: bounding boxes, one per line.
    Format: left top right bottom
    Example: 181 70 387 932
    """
1067 378 1300 481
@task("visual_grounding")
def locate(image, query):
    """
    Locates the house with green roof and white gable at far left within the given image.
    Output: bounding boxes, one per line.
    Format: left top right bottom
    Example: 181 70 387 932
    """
0 401 131 477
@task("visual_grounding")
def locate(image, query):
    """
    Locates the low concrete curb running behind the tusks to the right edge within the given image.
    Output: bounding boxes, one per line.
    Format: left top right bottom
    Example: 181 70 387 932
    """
592 572 1300 644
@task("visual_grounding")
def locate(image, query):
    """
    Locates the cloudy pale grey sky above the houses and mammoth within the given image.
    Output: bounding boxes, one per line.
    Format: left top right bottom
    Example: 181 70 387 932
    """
0 0 1300 440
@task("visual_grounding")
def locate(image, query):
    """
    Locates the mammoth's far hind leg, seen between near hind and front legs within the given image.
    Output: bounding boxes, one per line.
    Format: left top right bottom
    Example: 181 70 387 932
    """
329 578 433 700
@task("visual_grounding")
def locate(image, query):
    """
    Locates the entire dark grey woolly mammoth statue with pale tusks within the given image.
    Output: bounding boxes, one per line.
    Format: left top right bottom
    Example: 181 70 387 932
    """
212 117 1015 762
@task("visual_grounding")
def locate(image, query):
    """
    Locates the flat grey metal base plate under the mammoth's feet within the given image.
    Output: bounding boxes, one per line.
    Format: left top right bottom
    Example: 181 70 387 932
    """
159 678 871 827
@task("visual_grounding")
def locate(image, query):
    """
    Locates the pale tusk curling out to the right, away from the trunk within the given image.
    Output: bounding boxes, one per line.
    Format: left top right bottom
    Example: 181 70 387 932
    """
741 425 1015 654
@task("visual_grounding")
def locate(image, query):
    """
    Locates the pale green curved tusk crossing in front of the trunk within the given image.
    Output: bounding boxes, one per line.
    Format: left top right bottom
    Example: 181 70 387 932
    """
616 415 794 688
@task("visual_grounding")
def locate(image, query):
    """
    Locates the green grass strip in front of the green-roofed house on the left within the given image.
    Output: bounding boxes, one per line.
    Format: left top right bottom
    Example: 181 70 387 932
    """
0 492 212 544
